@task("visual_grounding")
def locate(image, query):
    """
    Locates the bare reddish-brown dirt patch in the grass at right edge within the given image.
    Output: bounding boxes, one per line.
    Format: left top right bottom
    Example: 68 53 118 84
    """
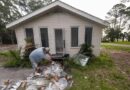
109 51 130 80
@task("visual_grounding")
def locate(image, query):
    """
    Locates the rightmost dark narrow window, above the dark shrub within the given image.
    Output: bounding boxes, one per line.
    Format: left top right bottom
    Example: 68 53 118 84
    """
85 27 92 45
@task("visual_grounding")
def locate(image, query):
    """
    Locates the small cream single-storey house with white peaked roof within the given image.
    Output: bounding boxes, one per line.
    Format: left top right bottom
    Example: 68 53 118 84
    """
6 1 107 56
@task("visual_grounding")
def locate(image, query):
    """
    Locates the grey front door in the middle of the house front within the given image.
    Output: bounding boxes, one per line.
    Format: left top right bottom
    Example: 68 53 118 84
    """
55 29 64 54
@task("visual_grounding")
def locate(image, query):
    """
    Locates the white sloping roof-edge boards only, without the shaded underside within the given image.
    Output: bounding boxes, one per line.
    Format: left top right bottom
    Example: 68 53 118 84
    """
6 0 108 29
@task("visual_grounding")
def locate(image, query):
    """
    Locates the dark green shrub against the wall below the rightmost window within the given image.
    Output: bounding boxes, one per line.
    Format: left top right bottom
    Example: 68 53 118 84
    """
79 43 92 56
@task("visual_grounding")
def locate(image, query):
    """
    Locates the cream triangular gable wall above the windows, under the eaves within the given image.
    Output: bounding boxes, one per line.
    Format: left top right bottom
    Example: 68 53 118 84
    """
17 12 96 28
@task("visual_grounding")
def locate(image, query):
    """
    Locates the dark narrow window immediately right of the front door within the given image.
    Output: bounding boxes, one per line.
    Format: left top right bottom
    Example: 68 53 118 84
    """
71 27 78 47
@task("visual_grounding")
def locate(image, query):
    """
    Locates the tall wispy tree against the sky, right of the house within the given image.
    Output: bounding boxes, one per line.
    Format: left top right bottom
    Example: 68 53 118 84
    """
106 3 126 42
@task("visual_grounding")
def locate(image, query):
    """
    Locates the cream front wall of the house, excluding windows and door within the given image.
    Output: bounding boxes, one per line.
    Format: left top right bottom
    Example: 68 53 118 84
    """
15 12 102 56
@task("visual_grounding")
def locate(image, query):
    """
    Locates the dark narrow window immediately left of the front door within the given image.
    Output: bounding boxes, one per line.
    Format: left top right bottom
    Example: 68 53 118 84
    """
40 28 49 47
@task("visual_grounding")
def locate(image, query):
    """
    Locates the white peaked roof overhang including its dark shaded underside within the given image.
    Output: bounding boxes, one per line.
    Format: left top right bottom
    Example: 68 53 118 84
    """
6 1 108 28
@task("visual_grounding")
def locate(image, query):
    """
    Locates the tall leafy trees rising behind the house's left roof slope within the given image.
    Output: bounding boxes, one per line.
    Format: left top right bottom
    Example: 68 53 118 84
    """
0 0 52 43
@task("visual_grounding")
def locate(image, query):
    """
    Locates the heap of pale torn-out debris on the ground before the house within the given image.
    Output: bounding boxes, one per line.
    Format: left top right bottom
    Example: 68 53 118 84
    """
0 62 73 90
